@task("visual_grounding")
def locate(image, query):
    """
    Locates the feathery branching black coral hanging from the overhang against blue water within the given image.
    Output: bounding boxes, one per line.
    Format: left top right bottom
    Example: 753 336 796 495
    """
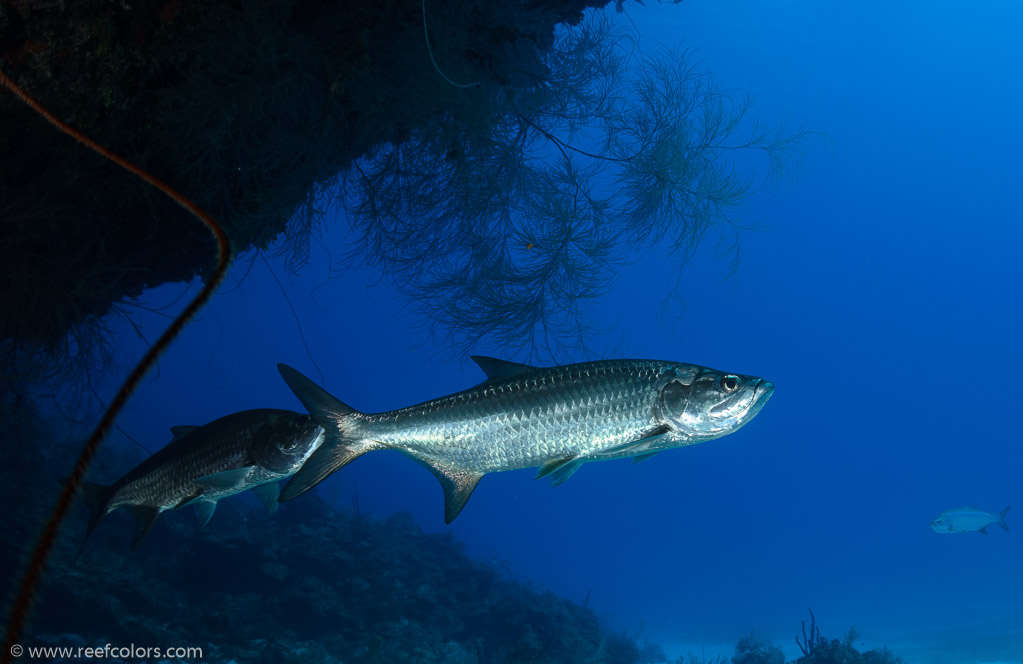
333 14 809 356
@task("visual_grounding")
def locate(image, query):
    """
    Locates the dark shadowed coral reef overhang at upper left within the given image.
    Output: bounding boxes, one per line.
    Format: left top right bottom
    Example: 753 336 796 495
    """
0 0 606 372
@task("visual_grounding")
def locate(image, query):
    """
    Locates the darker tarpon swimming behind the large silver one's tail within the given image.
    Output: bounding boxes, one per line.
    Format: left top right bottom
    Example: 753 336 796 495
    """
83 409 323 549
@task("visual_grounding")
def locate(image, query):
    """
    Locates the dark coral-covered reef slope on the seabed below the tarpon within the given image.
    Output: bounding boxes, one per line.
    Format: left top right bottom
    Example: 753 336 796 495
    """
0 400 654 664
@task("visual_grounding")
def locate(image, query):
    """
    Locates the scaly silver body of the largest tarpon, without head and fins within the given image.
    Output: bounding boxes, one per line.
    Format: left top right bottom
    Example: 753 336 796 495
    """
356 360 678 473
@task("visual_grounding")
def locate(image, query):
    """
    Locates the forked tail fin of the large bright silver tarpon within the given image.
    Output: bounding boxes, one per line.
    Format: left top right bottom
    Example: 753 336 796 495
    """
277 364 384 502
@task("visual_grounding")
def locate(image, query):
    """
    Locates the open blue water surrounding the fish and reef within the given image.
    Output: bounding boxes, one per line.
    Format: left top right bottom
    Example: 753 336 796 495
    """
81 0 1023 662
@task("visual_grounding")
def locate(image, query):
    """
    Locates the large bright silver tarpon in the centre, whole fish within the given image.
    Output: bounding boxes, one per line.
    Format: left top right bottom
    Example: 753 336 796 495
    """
277 357 774 523
